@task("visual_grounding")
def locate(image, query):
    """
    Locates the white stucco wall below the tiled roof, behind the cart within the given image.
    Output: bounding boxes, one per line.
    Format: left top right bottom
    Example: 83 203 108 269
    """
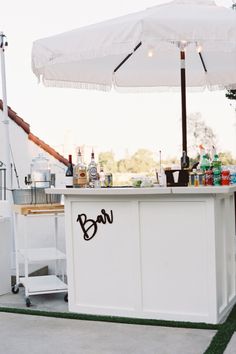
0 110 66 273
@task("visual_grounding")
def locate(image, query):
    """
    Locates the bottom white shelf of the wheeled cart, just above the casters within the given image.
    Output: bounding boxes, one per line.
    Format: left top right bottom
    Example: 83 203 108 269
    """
20 275 67 295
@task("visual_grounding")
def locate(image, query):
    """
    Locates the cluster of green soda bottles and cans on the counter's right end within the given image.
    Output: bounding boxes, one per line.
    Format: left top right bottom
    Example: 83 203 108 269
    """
189 149 236 187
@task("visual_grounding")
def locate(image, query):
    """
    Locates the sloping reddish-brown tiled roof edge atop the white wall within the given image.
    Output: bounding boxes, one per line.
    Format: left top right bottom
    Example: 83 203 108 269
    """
0 100 69 166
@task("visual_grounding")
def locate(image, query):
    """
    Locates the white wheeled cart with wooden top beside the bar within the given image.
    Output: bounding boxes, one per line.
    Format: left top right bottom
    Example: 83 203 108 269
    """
12 204 68 307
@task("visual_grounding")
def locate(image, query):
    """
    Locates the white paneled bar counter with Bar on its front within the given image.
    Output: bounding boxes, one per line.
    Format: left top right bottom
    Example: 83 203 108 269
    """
47 186 236 323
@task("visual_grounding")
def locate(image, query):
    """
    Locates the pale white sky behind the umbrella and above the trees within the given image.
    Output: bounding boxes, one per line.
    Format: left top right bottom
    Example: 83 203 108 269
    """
0 0 236 162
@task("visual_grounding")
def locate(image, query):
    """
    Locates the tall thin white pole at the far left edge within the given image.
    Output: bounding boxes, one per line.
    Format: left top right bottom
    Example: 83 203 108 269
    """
0 32 11 200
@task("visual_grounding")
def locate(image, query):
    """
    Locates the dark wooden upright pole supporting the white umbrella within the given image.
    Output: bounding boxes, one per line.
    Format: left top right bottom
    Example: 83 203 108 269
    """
180 50 189 169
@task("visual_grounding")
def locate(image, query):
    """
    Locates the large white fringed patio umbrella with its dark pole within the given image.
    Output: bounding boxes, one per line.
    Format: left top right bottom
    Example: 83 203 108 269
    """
32 0 236 167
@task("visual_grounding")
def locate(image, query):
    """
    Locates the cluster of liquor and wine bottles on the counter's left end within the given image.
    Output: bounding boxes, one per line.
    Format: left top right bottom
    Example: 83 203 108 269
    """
65 149 113 188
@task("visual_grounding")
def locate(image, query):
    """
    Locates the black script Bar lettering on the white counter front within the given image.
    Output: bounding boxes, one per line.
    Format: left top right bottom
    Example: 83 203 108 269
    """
76 209 113 241
